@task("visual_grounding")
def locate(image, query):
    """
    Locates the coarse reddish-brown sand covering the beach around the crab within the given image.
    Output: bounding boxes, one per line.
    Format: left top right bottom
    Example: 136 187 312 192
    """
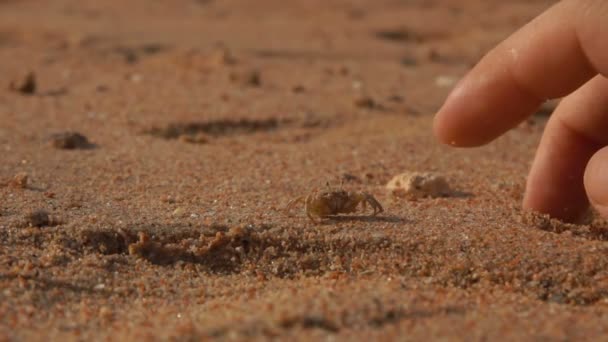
0 0 608 340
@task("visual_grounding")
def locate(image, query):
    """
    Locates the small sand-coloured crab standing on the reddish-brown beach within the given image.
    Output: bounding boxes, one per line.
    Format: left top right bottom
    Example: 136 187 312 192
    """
285 184 384 223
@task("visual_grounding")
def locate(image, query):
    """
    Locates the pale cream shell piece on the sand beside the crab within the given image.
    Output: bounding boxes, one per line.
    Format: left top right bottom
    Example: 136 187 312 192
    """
386 172 451 198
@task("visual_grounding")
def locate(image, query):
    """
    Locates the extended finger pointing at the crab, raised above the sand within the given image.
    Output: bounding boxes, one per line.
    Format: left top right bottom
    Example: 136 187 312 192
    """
434 0 608 146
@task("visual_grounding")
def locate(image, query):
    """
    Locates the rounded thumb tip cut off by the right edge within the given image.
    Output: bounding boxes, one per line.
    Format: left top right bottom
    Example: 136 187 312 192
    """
585 147 608 218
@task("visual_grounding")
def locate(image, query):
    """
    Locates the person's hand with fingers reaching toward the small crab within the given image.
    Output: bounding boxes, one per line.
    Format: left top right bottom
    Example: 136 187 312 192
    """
434 0 608 221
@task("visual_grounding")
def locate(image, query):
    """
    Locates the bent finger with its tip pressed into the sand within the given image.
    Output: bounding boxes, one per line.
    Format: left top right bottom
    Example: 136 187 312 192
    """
524 76 608 221
